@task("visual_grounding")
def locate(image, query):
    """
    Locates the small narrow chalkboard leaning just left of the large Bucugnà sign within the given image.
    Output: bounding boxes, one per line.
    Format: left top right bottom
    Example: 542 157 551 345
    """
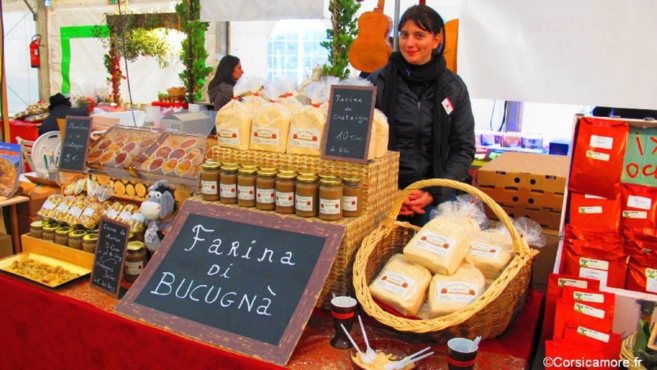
91 218 130 297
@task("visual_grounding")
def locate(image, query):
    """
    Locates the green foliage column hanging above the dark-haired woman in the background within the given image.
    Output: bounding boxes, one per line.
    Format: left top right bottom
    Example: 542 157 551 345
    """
176 0 212 103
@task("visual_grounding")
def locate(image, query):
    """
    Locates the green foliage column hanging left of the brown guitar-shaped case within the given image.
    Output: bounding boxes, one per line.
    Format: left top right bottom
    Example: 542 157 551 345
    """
321 0 360 78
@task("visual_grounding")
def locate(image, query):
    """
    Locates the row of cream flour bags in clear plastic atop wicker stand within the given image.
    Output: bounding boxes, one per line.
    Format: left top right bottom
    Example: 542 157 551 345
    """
215 77 388 159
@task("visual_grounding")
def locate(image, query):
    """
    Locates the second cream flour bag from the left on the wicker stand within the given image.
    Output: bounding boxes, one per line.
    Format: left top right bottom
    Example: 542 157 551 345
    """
249 103 292 153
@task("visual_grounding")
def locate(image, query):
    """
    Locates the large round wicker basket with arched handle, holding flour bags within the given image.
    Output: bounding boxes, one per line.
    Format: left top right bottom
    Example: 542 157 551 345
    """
353 179 537 342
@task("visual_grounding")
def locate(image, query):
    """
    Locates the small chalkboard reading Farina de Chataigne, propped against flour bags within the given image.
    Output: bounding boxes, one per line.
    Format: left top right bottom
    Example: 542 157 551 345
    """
322 86 376 162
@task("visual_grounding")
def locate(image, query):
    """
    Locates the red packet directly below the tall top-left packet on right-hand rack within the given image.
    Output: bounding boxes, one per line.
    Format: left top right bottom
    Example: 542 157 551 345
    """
569 192 621 232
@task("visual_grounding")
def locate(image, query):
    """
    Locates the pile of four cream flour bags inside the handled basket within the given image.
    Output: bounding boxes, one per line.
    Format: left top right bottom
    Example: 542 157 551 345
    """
370 201 513 319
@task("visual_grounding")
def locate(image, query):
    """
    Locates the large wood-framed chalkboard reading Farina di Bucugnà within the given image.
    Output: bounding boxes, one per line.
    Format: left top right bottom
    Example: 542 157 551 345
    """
116 200 344 365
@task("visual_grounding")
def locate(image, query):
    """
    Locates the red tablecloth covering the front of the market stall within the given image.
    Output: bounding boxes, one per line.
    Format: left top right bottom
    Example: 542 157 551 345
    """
0 274 543 370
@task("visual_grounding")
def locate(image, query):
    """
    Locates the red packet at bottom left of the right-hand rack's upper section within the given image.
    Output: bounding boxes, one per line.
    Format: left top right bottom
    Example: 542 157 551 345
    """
560 238 627 288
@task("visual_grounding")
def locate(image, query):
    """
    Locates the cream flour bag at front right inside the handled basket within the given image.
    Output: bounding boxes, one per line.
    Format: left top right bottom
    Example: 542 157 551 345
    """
429 262 486 318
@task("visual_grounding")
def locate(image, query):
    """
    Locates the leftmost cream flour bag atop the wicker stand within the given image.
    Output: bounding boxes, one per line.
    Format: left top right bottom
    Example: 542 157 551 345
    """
215 99 253 150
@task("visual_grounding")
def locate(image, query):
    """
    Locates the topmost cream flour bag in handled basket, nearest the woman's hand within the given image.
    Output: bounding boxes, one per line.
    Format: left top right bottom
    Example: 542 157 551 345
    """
404 216 480 275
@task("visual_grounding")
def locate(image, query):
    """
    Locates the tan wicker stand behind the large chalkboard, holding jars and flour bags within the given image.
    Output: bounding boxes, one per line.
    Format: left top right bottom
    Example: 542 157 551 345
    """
209 145 399 307
